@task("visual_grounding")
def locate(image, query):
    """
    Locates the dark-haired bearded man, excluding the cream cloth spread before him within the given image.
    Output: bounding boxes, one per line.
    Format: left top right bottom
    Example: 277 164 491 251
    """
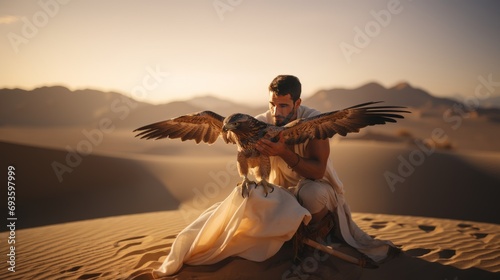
256 75 396 262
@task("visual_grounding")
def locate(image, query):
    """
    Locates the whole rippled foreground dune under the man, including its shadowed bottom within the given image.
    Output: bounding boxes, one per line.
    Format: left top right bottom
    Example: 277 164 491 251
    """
0 211 500 280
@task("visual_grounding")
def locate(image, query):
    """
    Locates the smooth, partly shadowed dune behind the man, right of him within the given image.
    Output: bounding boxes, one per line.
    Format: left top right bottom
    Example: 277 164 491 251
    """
332 142 500 224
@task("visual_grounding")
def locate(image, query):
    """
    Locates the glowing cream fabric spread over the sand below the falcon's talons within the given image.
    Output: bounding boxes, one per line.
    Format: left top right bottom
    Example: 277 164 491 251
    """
153 183 311 276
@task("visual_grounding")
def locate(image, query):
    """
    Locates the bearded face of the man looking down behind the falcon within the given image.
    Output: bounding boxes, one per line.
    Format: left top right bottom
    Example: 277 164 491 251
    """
269 92 300 126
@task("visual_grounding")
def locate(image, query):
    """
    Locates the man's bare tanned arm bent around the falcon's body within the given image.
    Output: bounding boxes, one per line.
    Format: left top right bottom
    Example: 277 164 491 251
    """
257 139 330 179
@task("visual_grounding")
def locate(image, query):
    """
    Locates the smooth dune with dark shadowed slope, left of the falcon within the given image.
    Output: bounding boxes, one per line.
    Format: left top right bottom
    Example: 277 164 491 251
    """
0 142 244 230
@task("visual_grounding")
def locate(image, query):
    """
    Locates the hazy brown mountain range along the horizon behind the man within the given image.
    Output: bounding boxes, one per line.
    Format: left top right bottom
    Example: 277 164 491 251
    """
0 82 500 128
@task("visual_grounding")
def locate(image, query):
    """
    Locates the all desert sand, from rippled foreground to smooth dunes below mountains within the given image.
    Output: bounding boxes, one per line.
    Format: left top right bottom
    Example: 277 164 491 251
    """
0 127 500 280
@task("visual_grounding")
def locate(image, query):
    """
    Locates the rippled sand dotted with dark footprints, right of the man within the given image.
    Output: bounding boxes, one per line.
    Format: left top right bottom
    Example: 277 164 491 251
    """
353 213 500 272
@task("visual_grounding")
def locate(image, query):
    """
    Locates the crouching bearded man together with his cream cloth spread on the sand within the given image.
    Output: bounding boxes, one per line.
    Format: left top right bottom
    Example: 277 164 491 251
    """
153 76 393 279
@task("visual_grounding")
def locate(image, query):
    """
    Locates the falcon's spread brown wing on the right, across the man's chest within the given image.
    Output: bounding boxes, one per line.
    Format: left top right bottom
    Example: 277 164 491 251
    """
281 102 410 144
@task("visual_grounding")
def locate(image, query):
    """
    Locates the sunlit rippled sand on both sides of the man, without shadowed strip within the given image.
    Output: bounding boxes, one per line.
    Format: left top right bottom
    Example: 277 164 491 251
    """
0 211 500 280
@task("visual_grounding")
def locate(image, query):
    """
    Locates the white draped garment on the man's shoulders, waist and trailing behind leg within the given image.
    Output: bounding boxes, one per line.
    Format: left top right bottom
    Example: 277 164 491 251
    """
256 106 392 262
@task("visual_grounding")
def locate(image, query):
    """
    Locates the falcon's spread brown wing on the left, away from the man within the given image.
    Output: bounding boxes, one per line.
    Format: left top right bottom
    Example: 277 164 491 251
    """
134 111 236 144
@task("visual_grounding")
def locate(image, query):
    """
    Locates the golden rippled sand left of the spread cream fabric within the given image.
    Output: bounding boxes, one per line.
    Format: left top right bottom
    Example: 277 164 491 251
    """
0 212 187 280
